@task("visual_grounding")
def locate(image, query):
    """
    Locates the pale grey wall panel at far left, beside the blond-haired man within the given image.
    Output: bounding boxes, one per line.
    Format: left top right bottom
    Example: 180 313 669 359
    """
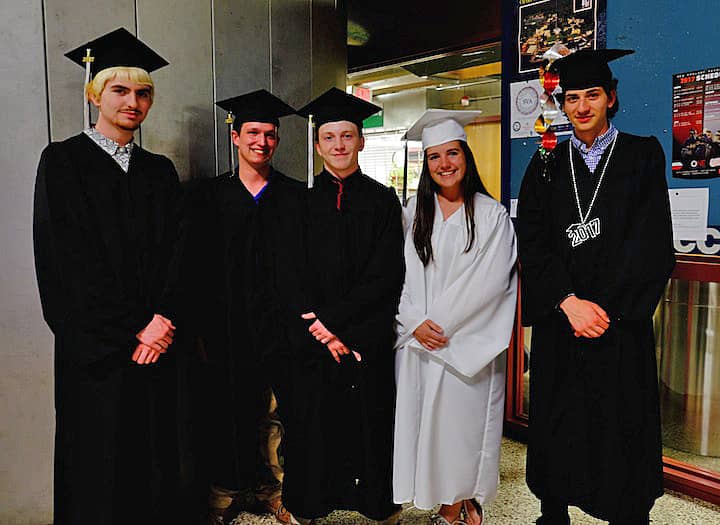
0 0 54 523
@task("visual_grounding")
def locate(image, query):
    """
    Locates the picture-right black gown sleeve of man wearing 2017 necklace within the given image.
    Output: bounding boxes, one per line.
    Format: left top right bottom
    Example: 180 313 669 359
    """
597 137 675 320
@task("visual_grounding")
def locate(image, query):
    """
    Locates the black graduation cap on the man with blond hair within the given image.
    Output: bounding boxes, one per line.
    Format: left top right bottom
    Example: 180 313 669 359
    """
65 27 168 74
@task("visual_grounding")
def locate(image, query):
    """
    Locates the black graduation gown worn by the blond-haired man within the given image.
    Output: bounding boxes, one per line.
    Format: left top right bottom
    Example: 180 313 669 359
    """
34 134 186 525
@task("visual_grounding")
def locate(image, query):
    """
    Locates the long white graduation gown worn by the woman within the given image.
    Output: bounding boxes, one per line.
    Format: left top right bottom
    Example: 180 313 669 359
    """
393 194 517 509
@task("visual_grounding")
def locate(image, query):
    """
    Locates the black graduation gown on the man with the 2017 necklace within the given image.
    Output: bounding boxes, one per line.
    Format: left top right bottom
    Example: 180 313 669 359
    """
517 133 674 521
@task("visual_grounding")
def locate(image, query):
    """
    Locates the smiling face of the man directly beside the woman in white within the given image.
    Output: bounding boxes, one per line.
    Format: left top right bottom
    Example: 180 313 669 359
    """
315 120 365 178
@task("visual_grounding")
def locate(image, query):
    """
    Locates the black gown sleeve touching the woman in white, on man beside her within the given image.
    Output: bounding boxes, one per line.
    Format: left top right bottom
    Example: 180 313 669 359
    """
315 189 405 333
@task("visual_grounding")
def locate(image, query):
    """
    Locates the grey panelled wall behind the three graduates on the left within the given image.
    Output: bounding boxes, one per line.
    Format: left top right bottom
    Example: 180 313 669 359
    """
0 0 346 525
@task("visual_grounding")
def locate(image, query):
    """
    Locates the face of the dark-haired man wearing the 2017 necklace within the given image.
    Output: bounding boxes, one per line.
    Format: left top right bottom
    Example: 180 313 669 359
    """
562 86 615 145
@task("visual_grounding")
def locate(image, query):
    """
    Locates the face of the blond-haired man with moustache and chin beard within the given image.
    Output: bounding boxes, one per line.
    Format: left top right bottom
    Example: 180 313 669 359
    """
90 78 152 142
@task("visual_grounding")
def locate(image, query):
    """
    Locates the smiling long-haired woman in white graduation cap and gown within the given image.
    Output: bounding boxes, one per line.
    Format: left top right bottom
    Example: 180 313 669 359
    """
393 110 517 525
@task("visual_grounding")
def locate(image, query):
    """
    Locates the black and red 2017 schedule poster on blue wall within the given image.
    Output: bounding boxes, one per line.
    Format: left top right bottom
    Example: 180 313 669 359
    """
672 67 720 179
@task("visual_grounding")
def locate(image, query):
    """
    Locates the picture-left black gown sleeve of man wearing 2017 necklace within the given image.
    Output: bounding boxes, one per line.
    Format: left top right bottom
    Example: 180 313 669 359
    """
517 149 574 326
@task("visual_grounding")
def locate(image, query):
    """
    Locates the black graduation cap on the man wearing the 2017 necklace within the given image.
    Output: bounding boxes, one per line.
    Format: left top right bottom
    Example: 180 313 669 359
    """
550 49 635 91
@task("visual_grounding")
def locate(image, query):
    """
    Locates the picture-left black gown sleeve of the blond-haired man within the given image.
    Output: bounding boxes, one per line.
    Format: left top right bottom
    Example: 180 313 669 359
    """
33 144 153 363
